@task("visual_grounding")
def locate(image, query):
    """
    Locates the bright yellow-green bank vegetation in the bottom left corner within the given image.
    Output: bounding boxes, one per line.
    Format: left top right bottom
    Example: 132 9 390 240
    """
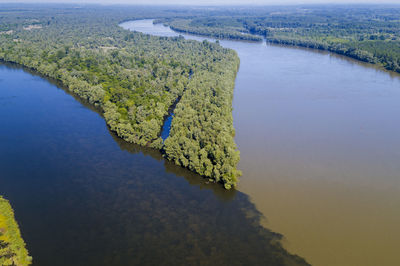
0 196 32 266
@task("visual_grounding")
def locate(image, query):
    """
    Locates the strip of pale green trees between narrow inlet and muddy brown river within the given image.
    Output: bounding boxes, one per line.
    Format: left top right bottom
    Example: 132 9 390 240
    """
165 41 240 189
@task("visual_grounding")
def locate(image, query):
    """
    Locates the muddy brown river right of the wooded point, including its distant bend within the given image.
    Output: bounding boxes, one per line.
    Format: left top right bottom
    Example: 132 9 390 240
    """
121 20 400 266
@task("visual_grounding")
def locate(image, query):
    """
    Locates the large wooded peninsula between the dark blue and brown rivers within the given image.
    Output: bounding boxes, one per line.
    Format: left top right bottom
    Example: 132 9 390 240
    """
0 5 240 189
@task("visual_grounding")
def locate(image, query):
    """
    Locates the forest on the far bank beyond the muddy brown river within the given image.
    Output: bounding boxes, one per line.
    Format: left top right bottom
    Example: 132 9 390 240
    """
159 5 400 73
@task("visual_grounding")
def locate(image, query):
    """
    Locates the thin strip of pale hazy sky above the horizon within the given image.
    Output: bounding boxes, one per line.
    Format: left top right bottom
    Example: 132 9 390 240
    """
0 0 400 5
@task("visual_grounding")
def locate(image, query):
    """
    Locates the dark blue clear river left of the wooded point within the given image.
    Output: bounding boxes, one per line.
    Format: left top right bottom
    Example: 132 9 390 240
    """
0 65 306 266
